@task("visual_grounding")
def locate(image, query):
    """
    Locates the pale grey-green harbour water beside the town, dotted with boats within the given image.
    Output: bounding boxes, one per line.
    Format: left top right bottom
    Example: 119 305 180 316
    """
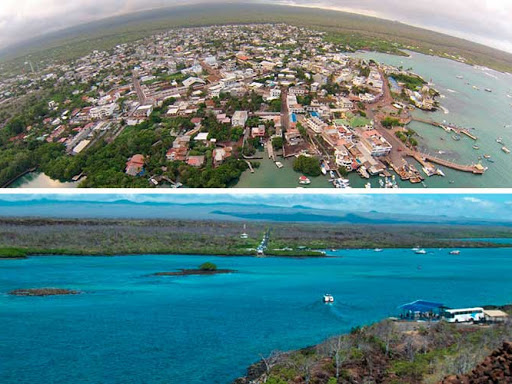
353 52 512 188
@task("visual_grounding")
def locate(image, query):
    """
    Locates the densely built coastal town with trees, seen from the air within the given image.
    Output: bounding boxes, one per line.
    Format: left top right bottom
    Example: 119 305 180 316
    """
0 24 485 188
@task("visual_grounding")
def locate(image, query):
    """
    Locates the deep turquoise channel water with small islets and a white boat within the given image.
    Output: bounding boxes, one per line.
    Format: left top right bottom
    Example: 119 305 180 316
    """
0 249 512 384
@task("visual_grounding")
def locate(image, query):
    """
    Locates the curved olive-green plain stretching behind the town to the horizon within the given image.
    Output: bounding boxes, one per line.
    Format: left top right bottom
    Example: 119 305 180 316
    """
0 3 512 72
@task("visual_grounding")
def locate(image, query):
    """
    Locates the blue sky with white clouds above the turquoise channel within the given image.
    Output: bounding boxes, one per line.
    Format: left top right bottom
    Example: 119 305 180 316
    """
0 190 512 221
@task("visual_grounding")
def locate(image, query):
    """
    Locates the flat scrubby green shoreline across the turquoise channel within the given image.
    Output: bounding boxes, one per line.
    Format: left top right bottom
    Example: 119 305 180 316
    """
0 218 512 257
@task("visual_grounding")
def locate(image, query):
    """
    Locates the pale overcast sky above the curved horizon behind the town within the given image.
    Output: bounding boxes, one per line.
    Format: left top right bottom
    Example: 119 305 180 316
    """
0 0 512 52
